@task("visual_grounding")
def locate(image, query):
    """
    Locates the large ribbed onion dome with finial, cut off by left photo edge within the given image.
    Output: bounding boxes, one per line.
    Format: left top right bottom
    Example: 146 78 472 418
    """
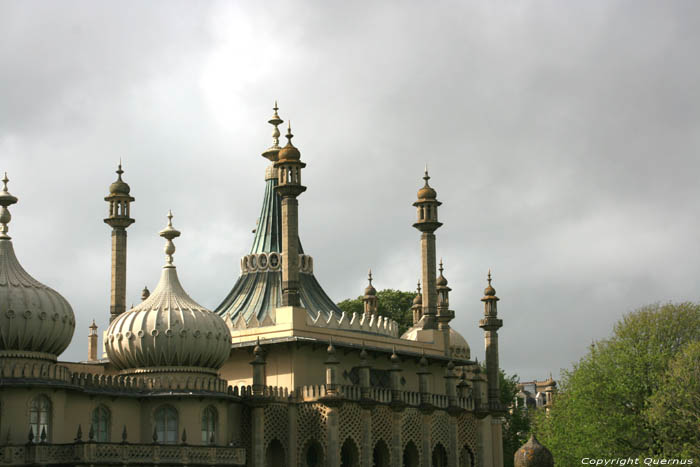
0 174 75 360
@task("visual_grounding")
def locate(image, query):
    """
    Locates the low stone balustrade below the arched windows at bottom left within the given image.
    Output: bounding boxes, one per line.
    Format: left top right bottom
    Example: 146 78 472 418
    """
0 441 246 466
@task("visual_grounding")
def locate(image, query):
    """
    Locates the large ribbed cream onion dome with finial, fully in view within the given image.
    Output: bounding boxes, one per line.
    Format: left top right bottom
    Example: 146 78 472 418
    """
105 213 231 372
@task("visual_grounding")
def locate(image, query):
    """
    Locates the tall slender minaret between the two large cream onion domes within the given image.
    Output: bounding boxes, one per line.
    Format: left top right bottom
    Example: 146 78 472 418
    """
104 162 134 322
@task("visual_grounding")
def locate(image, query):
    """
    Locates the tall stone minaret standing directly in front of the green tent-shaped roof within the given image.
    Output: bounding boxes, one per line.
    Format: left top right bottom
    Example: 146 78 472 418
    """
274 125 306 306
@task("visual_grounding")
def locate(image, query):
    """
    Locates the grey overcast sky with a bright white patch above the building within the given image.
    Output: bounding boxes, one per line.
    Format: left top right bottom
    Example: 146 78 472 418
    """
0 0 700 380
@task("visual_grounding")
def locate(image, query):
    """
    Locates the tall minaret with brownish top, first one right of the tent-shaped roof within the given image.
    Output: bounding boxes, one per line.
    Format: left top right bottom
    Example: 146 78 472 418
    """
413 167 442 329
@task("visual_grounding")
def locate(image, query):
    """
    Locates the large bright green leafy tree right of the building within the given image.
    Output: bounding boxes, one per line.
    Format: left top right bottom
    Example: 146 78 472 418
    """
535 303 700 465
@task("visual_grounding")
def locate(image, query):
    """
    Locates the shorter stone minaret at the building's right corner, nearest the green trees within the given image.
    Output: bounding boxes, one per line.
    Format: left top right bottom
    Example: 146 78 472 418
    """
479 270 503 410
